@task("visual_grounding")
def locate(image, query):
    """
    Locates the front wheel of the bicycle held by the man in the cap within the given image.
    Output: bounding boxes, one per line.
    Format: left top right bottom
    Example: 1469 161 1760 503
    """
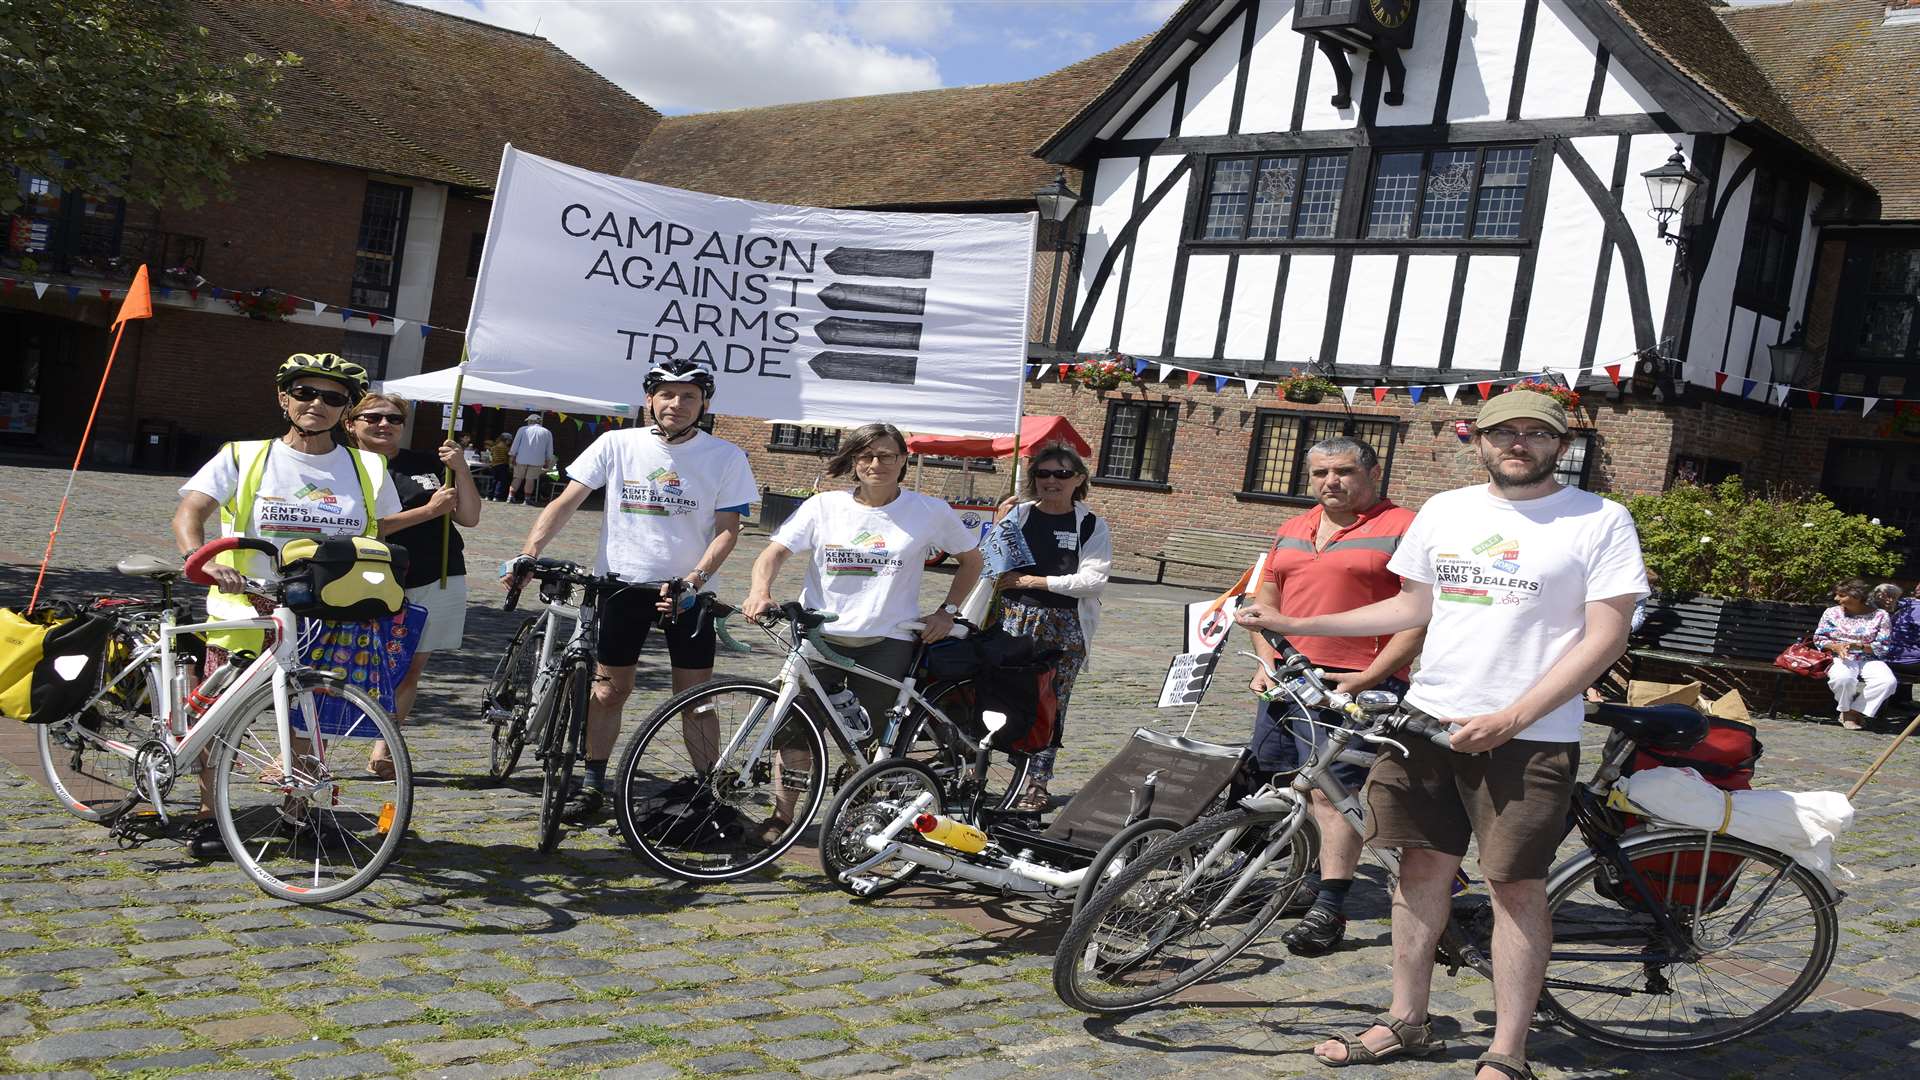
1054 807 1319 1015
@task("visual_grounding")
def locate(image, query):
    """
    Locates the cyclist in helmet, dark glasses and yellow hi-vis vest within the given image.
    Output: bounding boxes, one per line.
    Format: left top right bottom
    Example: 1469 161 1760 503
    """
173 352 399 857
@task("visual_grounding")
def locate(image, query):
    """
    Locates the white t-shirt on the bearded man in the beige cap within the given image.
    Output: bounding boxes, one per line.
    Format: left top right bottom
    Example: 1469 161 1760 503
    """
1386 484 1647 742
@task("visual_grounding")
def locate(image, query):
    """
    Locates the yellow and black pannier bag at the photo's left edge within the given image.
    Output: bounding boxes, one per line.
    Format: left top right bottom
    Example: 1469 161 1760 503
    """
0 603 113 724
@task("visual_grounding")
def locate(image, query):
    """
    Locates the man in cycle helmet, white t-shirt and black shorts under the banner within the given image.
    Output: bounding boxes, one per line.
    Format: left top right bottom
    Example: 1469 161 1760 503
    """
515 359 756 821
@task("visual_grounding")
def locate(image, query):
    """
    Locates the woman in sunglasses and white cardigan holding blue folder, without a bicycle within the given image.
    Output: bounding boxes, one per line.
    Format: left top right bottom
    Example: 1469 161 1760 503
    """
995 442 1114 811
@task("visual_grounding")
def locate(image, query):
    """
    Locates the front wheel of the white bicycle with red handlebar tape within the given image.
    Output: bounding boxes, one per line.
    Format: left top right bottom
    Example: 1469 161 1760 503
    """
207 671 413 903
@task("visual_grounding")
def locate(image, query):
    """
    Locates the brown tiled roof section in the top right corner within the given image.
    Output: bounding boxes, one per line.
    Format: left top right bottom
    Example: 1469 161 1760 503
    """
1720 0 1920 221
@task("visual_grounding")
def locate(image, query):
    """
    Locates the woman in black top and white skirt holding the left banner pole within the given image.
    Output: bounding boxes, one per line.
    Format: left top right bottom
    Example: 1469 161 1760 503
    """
348 394 480 780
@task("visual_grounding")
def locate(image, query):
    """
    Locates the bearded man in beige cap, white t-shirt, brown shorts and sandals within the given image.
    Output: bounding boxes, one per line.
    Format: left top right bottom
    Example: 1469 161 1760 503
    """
1236 390 1647 1080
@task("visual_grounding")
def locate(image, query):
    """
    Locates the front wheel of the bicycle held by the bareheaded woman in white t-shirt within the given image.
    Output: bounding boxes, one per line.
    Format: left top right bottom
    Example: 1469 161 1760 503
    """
614 678 829 882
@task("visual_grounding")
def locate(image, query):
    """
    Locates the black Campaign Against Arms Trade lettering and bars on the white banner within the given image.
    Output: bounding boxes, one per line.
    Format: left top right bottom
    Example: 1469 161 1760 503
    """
561 202 933 384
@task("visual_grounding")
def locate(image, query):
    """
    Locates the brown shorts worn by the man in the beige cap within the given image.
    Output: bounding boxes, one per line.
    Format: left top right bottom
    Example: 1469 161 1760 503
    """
1367 718 1580 882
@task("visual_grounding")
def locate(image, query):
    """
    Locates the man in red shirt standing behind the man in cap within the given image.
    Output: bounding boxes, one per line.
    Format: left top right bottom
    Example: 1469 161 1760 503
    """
1252 436 1427 945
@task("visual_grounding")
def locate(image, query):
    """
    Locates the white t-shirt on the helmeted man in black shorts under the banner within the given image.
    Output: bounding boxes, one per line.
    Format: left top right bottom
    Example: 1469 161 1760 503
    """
566 429 758 580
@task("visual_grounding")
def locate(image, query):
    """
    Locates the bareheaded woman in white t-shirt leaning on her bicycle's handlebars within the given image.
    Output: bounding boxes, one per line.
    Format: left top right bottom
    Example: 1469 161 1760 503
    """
741 423 981 832
